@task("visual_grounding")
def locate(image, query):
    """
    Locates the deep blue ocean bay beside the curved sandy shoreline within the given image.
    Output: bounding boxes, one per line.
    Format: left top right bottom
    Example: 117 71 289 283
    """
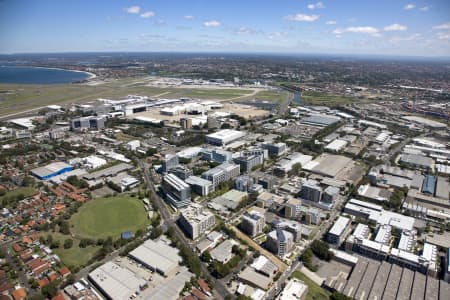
0 66 89 84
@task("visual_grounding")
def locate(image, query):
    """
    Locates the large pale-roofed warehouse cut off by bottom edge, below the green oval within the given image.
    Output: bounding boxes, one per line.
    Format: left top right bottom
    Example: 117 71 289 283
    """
88 262 147 300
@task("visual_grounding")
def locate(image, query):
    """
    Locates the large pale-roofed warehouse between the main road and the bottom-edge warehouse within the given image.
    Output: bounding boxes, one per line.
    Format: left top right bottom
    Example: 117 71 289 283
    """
128 239 182 277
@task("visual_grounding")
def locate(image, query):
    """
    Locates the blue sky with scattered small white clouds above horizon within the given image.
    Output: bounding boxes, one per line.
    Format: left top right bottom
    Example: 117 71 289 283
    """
0 0 450 57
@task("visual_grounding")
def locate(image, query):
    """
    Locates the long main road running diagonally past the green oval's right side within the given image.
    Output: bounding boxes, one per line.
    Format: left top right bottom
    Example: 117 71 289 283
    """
138 160 228 299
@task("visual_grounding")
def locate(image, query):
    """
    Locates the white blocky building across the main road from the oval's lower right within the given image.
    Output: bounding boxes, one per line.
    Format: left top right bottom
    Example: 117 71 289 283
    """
178 203 216 240
